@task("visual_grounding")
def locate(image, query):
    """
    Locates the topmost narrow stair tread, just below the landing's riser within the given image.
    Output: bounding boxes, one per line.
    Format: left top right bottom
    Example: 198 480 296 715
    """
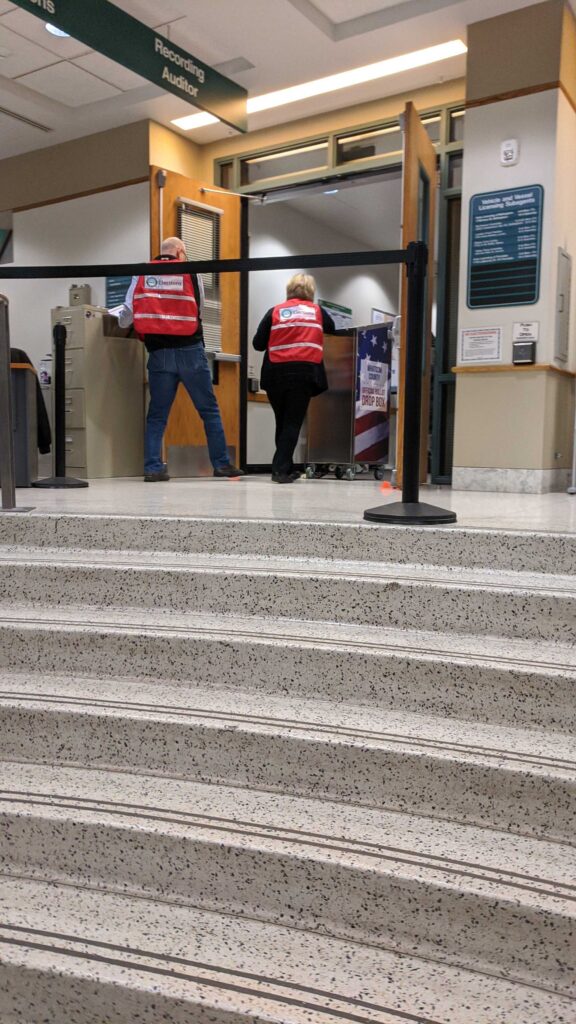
0 546 576 597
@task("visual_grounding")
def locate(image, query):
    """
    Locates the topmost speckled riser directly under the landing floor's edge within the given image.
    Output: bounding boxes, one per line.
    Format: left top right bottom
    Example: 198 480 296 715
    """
0 512 576 573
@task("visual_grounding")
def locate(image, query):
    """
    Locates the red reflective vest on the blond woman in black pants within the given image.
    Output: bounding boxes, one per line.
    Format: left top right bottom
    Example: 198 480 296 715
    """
268 299 324 362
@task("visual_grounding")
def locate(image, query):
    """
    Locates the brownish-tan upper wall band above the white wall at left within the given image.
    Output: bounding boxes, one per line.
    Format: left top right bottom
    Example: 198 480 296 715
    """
0 121 149 210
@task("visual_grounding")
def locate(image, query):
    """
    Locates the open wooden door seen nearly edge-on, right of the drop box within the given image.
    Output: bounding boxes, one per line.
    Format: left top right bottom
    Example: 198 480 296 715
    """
396 102 437 485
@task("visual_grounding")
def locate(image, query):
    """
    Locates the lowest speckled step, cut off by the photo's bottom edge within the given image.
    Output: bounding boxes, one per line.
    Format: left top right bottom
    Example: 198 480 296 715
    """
0 878 574 1024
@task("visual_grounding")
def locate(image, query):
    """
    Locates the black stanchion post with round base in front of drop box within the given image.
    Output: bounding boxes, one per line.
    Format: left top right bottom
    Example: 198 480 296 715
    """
364 242 456 526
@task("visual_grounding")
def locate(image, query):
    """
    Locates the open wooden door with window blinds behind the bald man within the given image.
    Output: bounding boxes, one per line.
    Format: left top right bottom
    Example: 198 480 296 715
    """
151 167 241 465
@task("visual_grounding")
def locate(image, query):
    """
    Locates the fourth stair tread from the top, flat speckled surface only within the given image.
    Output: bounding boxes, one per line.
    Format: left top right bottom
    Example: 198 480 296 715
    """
0 761 576 916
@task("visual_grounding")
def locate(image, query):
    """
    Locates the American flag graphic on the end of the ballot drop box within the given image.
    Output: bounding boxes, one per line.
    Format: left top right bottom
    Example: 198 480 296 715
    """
354 324 392 463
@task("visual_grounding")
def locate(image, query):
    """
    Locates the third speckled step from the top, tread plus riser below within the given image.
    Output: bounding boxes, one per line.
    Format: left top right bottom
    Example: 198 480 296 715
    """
0 673 576 842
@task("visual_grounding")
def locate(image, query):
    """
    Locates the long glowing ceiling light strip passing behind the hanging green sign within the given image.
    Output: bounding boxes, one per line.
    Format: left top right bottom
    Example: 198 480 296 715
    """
171 39 467 131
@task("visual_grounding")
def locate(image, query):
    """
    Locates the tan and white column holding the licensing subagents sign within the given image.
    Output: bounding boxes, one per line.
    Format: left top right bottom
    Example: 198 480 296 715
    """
453 0 576 493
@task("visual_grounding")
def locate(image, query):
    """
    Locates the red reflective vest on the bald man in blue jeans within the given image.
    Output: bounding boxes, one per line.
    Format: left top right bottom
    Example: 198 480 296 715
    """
132 259 198 335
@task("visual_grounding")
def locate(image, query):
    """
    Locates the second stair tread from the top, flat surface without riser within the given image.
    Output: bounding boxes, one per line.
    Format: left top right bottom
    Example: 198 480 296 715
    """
0 601 576 676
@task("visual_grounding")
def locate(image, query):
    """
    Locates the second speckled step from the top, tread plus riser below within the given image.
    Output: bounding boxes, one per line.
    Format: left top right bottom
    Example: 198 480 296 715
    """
0 604 576 734
